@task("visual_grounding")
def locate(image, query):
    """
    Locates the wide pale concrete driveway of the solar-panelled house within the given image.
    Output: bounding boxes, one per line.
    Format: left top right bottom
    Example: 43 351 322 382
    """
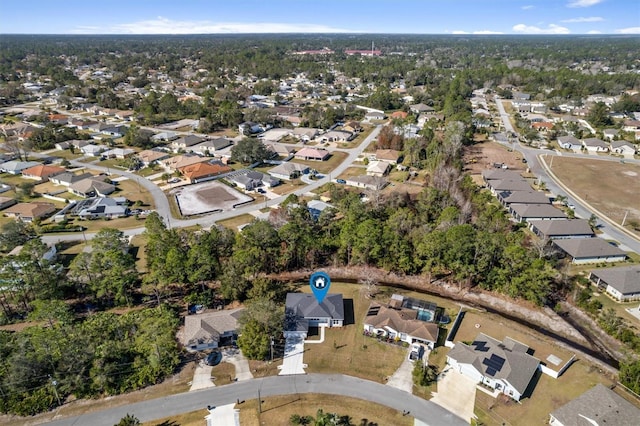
430 367 476 422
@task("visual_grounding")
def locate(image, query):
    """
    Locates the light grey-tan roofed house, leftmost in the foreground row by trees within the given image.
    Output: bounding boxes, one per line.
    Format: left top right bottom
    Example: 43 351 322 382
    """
180 308 244 352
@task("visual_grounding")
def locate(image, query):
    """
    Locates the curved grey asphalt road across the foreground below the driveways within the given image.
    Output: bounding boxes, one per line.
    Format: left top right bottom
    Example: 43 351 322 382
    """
48 374 468 426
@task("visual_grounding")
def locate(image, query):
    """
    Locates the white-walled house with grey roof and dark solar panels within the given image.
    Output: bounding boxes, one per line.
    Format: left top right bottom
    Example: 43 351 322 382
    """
447 333 540 401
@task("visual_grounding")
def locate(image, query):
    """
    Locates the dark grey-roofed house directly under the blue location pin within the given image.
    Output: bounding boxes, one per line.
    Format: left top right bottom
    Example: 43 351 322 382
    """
284 293 344 338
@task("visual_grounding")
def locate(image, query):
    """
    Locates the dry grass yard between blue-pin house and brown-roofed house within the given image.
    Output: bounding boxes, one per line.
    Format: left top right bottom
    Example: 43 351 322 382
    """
299 283 406 383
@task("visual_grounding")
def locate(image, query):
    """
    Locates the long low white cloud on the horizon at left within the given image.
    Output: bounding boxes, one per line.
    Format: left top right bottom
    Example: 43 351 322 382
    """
72 16 352 34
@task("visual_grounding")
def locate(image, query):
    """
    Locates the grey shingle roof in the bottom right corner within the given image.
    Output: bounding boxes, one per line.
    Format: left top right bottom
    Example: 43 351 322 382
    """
549 384 640 426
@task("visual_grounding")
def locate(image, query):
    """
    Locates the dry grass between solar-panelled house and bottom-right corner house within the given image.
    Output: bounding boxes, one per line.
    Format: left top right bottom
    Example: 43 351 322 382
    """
475 360 612 425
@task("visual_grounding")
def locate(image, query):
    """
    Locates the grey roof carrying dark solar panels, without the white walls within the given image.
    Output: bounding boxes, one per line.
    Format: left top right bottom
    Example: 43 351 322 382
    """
448 333 540 395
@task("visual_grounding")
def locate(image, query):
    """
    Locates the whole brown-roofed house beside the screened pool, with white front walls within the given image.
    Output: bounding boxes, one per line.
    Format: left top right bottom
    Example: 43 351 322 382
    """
364 302 439 349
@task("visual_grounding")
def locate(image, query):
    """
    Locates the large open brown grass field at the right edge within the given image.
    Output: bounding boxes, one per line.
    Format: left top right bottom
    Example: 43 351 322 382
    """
545 156 640 236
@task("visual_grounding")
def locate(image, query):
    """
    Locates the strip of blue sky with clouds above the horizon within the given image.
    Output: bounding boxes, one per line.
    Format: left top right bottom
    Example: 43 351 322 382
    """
0 0 640 34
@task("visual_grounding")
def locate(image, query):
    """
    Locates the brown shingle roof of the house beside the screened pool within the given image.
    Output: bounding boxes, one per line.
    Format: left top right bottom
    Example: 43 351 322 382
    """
364 302 438 342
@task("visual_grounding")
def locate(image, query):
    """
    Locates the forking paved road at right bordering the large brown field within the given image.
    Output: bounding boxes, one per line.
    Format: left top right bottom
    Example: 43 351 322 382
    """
495 98 640 253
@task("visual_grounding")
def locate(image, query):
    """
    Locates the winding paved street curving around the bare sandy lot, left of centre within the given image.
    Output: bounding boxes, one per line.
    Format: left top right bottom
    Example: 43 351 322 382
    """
42 125 382 243
